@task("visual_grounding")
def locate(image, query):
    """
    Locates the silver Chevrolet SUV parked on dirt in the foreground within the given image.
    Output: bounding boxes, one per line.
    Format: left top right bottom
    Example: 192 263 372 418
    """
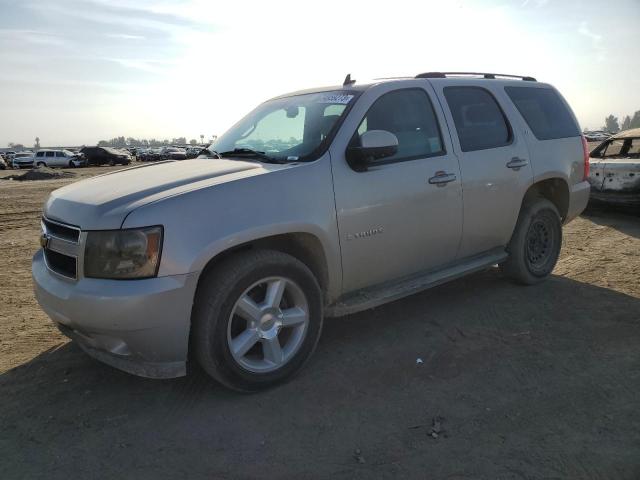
33 72 589 391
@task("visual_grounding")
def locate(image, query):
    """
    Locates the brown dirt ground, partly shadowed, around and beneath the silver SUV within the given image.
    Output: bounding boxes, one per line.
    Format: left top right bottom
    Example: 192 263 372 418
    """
0 163 640 479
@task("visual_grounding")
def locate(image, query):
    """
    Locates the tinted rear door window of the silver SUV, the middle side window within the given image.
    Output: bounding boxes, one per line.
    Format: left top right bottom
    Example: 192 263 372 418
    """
444 87 513 152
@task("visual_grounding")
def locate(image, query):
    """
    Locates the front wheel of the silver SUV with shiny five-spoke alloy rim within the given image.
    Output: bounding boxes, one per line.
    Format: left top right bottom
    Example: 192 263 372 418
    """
191 250 323 392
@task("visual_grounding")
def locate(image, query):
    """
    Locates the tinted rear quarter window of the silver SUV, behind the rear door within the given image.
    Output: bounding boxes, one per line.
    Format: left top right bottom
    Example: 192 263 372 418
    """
505 87 580 140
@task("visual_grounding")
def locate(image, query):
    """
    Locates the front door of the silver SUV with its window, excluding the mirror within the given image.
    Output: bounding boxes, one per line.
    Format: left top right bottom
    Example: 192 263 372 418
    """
331 86 462 292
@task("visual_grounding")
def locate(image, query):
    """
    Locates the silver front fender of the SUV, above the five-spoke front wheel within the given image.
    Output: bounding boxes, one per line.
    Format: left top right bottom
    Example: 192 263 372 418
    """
123 156 342 302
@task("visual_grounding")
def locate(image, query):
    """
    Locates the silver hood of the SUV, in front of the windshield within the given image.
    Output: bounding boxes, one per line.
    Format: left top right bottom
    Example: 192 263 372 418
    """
44 159 270 230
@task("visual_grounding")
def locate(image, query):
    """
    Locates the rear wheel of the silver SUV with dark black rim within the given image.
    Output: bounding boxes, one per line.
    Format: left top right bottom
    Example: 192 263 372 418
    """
502 197 562 285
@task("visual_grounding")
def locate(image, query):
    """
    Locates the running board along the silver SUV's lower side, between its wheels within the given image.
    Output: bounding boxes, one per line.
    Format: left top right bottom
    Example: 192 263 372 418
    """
325 248 509 317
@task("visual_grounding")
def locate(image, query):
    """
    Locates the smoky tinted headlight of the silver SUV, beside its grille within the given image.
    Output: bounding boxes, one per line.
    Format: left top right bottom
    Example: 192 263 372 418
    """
84 227 162 279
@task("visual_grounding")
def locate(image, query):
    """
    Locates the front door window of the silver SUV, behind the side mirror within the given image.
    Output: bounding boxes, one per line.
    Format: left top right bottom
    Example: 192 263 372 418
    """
352 88 445 163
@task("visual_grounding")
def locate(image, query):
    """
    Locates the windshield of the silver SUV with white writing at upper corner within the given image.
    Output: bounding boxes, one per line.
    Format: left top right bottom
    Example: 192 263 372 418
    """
209 90 359 161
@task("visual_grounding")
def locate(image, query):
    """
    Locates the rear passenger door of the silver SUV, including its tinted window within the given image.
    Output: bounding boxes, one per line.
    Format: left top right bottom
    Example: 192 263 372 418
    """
431 79 533 258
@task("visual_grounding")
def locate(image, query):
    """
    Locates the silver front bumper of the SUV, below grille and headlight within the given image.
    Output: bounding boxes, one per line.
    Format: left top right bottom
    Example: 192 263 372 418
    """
32 250 198 378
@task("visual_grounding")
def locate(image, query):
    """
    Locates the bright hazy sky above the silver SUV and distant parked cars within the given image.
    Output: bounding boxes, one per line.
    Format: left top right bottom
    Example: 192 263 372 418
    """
0 0 640 146
